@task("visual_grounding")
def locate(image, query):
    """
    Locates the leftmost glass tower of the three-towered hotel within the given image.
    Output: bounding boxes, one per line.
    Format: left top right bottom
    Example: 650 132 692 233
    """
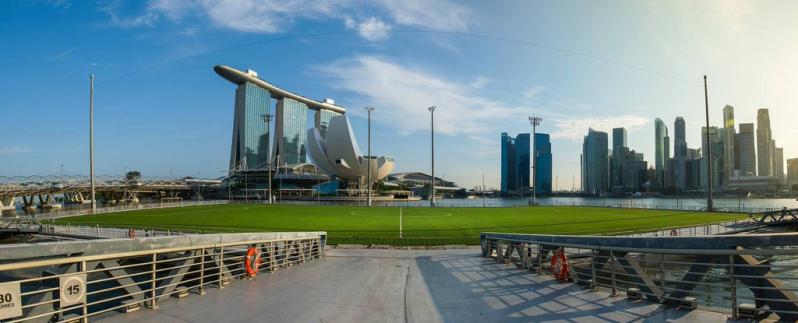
230 82 271 170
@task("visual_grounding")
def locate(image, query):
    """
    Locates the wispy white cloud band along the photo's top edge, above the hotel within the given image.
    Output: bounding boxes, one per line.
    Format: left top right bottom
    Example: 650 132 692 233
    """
106 0 470 36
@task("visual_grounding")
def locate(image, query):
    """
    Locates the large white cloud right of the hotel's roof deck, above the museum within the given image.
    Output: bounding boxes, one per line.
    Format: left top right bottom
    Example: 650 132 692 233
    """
317 56 527 140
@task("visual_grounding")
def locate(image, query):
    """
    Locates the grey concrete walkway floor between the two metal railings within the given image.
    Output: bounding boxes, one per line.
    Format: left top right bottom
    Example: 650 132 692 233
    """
102 249 726 322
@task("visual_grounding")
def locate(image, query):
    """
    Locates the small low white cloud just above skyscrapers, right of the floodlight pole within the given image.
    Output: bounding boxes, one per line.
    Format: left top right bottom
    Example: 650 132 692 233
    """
551 116 649 142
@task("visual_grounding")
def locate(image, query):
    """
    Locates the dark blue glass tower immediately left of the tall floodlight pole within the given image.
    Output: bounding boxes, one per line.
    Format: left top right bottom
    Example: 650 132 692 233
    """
501 132 531 194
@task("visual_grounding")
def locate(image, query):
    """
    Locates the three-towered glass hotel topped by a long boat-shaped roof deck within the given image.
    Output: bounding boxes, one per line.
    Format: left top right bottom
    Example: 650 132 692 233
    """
213 65 346 170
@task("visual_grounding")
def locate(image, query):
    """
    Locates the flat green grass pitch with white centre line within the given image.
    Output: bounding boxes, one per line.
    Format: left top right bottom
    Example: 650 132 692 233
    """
53 205 745 245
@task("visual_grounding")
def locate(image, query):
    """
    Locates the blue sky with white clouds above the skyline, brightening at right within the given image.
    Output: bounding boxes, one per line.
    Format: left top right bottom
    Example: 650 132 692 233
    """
0 0 798 189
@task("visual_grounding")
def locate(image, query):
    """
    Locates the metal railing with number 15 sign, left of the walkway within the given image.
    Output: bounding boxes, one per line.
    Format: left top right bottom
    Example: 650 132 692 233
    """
0 232 326 323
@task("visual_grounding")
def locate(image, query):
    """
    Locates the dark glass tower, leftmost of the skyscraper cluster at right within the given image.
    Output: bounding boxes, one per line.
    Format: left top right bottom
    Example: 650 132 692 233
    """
582 128 609 195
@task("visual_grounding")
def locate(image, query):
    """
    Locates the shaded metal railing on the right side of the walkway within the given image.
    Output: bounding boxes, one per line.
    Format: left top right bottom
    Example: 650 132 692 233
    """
481 233 798 320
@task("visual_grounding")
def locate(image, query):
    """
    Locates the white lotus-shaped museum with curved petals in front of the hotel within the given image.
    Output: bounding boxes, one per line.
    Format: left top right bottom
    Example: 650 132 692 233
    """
307 115 395 183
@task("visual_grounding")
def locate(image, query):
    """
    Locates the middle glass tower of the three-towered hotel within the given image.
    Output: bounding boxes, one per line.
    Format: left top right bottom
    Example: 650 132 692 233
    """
274 98 308 165
